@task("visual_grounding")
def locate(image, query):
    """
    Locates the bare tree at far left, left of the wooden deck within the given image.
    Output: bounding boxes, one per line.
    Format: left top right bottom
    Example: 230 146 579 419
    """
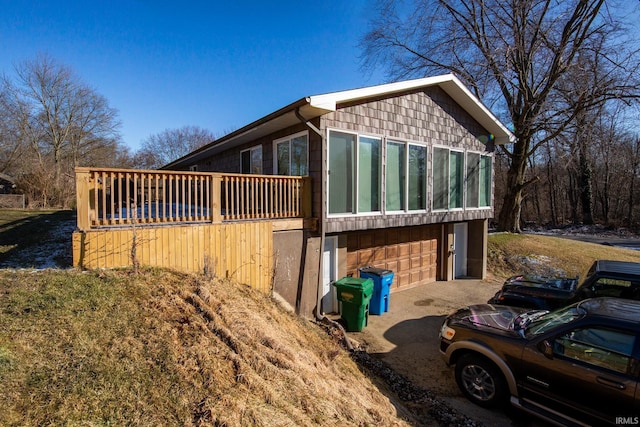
3 56 120 207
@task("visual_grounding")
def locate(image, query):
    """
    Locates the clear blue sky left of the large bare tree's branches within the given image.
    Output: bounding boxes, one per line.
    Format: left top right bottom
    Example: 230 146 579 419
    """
0 0 385 150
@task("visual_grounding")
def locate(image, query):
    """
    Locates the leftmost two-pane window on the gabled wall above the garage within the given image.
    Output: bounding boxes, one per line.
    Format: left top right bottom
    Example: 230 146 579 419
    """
329 131 382 214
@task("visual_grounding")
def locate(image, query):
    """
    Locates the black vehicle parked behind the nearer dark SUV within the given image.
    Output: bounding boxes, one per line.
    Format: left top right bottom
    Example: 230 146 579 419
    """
488 260 640 310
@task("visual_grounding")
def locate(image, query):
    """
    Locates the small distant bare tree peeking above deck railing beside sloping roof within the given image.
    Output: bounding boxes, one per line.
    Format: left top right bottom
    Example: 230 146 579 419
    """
134 126 216 169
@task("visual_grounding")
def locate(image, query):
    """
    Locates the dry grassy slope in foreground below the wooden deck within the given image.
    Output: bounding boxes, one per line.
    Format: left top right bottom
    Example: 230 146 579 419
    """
0 270 404 426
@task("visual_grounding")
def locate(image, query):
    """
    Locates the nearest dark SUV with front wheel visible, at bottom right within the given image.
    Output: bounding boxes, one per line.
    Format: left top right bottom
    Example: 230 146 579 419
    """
440 298 640 425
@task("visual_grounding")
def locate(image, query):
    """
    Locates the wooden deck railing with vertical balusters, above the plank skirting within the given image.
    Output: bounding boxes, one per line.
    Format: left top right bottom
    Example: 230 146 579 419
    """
76 168 311 230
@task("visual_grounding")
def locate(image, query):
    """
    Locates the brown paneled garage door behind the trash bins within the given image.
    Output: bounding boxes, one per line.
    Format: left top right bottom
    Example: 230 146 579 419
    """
347 225 440 290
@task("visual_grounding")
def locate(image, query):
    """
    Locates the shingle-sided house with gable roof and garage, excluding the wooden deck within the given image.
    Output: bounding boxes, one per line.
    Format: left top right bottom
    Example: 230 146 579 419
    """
163 74 514 316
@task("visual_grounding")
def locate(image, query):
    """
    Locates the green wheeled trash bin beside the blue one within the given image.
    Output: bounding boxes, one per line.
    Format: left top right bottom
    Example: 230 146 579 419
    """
333 277 373 332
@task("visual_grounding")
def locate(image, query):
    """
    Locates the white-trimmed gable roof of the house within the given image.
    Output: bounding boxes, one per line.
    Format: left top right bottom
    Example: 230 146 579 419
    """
162 74 515 169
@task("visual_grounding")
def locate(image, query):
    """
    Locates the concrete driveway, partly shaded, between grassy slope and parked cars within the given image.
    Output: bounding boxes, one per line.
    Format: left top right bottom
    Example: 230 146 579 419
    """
347 279 546 427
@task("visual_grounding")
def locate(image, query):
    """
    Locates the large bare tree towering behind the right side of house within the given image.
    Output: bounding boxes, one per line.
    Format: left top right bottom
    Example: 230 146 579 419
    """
362 0 639 232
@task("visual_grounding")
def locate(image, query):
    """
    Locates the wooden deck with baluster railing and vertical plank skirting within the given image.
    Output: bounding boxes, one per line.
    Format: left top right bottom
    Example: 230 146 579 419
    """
73 168 316 291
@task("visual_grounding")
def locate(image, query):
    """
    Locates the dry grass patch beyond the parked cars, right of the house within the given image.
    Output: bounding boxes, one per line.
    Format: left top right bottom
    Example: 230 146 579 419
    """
487 233 640 278
